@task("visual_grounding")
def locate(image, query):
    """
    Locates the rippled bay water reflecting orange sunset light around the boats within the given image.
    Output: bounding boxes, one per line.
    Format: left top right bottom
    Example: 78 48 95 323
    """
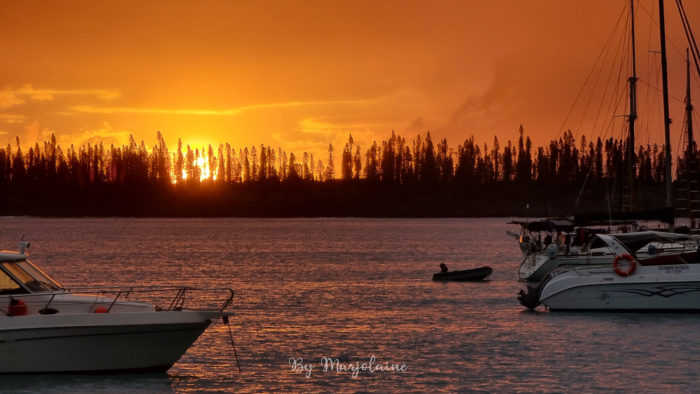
0 218 700 392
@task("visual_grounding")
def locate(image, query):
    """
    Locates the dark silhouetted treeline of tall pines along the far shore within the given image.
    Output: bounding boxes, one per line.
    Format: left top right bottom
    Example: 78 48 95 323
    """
0 126 700 217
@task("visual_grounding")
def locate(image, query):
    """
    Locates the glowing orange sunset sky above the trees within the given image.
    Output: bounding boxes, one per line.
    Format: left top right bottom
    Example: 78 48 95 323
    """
0 0 700 158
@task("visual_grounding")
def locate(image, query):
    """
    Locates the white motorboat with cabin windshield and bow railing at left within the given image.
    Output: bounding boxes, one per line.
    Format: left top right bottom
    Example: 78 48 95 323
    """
0 243 233 373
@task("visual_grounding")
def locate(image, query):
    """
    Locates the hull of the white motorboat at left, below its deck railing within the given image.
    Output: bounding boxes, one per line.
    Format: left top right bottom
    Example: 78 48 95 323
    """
0 311 216 373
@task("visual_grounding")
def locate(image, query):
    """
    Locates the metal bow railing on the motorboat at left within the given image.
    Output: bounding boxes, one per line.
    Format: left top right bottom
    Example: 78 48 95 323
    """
31 286 234 312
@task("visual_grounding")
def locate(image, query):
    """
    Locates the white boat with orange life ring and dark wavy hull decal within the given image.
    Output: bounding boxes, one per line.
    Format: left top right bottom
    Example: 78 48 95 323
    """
518 231 700 311
